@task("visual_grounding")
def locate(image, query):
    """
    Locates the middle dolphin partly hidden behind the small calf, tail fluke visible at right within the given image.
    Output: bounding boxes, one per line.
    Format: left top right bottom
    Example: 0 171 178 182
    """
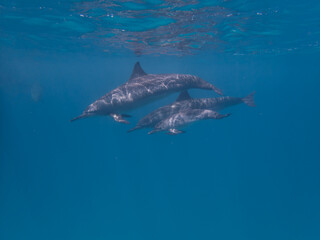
128 90 255 132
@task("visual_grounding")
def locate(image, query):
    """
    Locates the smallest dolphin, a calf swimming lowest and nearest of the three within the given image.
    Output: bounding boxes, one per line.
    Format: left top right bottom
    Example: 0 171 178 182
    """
148 109 230 135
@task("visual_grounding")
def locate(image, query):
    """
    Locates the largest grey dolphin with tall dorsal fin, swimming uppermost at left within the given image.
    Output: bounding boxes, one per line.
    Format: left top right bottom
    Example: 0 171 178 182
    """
71 62 222 123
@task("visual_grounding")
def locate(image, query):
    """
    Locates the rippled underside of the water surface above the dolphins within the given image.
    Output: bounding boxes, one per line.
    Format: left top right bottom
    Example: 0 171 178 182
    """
0 0 320 55
